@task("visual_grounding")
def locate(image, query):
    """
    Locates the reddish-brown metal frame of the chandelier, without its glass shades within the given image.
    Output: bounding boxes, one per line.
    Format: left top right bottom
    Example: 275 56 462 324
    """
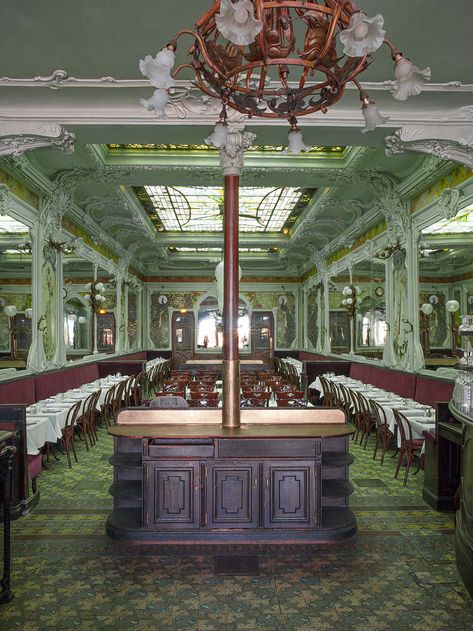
167 0 394 123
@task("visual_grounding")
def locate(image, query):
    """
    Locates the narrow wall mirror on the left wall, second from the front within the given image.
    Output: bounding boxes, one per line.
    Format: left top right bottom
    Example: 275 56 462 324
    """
62 253 94 361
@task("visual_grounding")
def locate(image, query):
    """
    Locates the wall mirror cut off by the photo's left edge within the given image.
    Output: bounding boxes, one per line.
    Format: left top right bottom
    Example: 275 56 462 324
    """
0 215 33 369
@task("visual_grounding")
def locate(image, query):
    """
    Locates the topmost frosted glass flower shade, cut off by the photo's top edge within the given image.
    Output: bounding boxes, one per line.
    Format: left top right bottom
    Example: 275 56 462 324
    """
215 0 263 46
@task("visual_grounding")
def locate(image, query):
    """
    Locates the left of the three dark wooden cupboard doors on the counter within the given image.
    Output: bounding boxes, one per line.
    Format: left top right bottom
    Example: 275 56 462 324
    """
144 462 201 529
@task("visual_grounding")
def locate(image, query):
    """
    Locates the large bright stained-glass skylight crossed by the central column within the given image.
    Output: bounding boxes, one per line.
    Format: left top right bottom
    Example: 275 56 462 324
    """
135 186 316 232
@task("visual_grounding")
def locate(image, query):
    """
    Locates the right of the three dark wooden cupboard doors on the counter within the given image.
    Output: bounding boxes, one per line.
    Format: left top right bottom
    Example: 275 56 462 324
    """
263 461 316 528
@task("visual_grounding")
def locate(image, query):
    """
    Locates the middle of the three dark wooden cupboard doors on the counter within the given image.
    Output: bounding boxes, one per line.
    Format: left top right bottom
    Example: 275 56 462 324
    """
207 462 259 528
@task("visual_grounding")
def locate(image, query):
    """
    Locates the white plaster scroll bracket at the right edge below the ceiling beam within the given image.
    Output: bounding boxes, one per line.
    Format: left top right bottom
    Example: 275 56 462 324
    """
385 124 473 168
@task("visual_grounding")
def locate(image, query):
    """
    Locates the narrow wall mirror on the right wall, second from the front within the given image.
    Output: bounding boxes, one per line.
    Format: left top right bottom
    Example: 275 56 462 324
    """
352 258 386 358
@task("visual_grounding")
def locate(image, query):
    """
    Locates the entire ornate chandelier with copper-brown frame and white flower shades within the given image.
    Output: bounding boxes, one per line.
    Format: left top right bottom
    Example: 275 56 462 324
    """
140 0 430 153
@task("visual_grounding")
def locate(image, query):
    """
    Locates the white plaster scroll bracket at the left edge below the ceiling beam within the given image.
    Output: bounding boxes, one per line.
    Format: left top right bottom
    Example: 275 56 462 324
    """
0 121 75 156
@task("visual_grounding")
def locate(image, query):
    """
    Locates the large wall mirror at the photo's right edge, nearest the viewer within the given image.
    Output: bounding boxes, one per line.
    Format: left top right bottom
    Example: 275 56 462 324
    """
418 205 473 368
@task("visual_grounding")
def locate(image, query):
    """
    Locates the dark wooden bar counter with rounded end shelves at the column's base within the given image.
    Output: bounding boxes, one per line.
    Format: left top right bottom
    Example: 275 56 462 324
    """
107 408 356 544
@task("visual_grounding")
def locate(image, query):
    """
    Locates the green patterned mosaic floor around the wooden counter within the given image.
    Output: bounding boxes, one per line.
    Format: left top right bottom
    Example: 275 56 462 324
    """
0 431 473 631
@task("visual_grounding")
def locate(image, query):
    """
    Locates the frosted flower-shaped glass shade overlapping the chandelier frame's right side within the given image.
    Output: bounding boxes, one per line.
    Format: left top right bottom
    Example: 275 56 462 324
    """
340 12 386 57
